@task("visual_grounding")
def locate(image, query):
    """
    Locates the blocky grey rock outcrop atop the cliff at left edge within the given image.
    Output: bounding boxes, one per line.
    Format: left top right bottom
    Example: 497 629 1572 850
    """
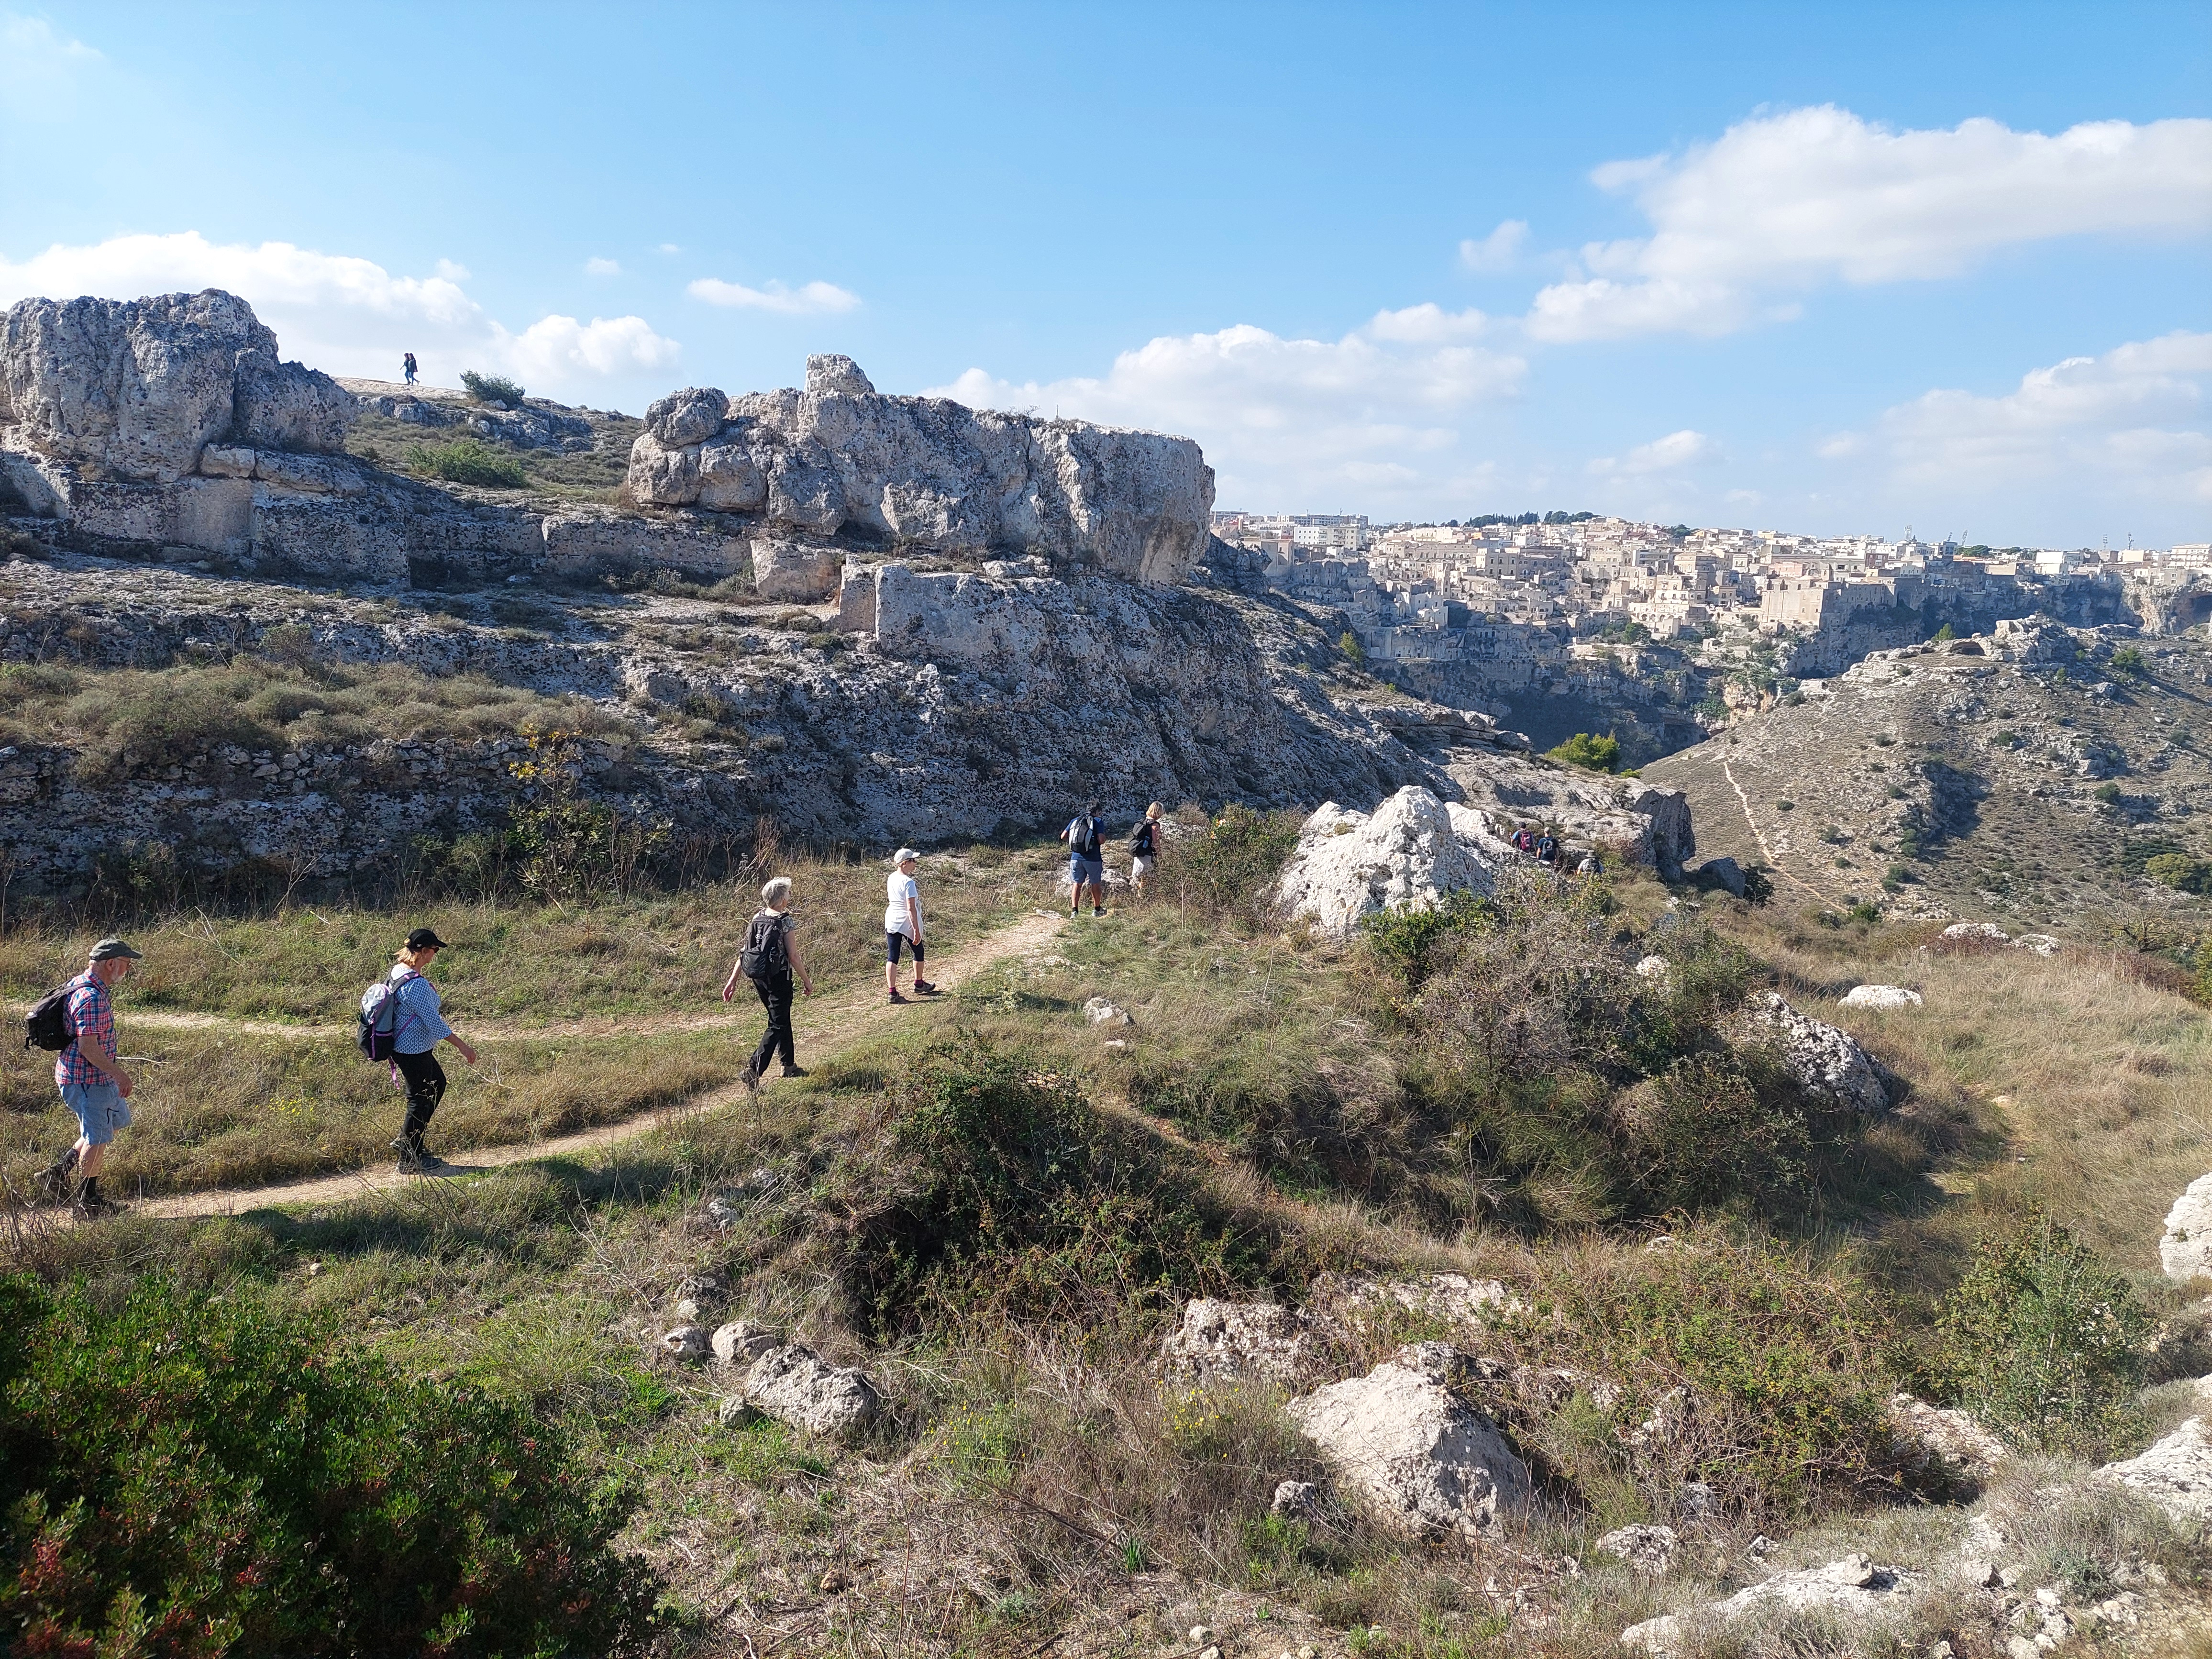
0 288 356 485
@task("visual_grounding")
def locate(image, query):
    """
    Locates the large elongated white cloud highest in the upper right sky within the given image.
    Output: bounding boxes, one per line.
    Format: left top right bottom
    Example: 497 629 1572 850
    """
1526 104 2212 341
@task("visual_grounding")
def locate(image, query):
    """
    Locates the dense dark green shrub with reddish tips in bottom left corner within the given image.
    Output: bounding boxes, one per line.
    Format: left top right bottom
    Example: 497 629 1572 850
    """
0 1279 657 1657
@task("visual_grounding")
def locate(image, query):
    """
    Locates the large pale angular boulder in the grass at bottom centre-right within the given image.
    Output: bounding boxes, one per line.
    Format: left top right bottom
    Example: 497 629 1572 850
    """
1285 1343 1531 1535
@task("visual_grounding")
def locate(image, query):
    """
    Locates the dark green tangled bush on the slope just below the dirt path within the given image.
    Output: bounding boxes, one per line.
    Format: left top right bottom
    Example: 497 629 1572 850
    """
852 1044 1272 1327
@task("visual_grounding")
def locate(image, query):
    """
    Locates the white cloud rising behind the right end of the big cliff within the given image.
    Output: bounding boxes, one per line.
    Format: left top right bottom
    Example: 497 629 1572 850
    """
933 305 1526 511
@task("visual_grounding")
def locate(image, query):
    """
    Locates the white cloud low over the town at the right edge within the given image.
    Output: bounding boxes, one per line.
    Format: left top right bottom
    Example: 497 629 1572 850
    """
1849 332 2212 507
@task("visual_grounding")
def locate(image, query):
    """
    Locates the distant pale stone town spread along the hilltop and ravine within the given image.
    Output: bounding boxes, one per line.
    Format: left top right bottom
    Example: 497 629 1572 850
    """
1212 511 2212 756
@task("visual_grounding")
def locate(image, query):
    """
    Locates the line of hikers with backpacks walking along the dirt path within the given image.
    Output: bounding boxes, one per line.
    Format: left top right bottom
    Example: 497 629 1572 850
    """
24 809 1185 1215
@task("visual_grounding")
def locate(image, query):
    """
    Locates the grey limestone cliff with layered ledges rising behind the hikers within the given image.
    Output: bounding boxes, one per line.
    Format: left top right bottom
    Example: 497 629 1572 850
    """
0 292 1690 891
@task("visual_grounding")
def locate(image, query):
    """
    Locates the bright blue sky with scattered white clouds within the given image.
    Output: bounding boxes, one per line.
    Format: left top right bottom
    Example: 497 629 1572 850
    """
0 0 2212 544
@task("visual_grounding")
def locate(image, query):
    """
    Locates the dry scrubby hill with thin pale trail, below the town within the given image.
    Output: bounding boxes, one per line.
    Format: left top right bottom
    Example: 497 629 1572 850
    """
1644 619 2212 931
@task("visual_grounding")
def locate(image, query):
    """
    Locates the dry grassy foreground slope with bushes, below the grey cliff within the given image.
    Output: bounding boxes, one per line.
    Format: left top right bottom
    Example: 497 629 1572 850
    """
0 849 2212 1659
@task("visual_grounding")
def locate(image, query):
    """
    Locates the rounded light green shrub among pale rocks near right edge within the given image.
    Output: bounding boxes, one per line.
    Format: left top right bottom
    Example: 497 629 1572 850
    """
1938 1212 2150 1456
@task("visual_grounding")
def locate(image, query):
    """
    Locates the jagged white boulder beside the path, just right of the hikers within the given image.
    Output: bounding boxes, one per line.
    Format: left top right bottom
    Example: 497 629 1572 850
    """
1276 783 1497 938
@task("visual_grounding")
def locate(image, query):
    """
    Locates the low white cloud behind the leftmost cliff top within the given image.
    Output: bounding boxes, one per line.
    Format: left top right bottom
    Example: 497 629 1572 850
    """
0 230 679 396
